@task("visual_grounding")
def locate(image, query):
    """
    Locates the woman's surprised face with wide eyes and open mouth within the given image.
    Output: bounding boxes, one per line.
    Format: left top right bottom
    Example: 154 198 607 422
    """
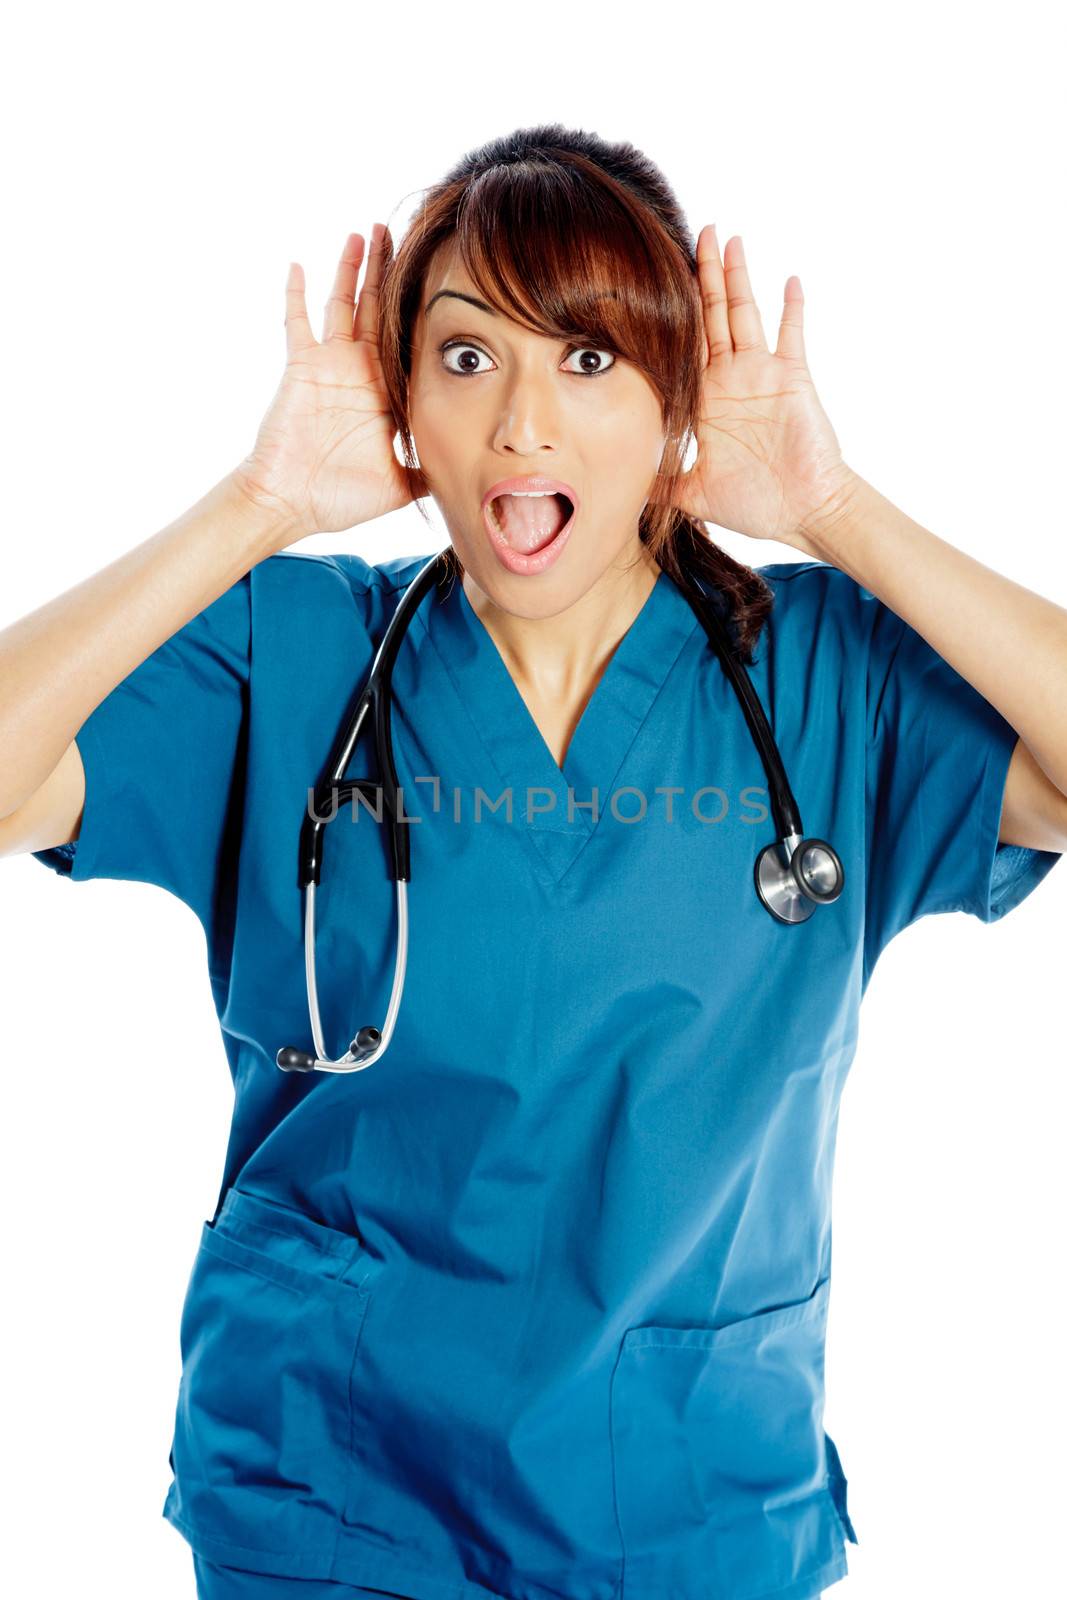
408 245 665 618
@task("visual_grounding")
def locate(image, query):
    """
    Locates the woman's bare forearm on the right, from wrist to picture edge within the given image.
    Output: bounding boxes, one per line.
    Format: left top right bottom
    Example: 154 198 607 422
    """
795 475 1067 795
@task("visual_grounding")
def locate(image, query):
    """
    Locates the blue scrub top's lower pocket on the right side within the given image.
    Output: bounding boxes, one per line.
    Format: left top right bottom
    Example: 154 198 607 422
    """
611 1278 854 1600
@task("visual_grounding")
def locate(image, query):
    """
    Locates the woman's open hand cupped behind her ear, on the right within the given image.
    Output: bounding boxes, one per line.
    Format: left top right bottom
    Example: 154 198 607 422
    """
670 226 856 549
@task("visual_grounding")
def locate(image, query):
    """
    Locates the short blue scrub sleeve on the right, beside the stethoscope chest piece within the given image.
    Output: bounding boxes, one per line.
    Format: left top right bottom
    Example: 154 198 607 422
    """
861 590 1059 973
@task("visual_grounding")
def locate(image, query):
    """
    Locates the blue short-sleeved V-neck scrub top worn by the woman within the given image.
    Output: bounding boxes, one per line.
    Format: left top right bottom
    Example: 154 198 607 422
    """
35 552 1059 1600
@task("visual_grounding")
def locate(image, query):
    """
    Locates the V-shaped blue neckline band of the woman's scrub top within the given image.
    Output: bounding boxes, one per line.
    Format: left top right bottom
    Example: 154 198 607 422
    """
416 570 701 882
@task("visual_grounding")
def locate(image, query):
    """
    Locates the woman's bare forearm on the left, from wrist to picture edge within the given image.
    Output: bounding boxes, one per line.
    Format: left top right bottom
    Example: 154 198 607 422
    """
0 474 309 818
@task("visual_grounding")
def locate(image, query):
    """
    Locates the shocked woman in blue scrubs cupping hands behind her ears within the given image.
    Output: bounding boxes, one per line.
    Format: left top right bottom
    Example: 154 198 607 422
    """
0 126 1067 1600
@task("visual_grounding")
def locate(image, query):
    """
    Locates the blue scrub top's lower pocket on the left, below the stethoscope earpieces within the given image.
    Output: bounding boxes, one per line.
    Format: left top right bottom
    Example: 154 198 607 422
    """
163 1189 384 1576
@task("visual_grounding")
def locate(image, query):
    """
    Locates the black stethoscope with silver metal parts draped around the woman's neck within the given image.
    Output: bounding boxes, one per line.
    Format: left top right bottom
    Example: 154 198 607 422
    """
275 550 845 1072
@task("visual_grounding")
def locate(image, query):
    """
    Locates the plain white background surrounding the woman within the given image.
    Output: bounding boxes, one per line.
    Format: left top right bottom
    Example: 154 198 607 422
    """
0 0 1067 1600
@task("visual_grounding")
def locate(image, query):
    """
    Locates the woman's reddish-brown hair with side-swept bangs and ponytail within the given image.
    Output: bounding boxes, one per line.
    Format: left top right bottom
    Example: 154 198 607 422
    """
379 123 773 664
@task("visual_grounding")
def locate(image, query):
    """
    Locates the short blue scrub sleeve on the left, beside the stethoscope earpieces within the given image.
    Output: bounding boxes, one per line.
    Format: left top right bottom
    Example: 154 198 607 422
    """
32 574 251 941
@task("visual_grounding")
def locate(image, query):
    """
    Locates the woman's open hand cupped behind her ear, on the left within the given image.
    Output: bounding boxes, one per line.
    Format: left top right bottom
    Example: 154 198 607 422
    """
234 222 427 542
